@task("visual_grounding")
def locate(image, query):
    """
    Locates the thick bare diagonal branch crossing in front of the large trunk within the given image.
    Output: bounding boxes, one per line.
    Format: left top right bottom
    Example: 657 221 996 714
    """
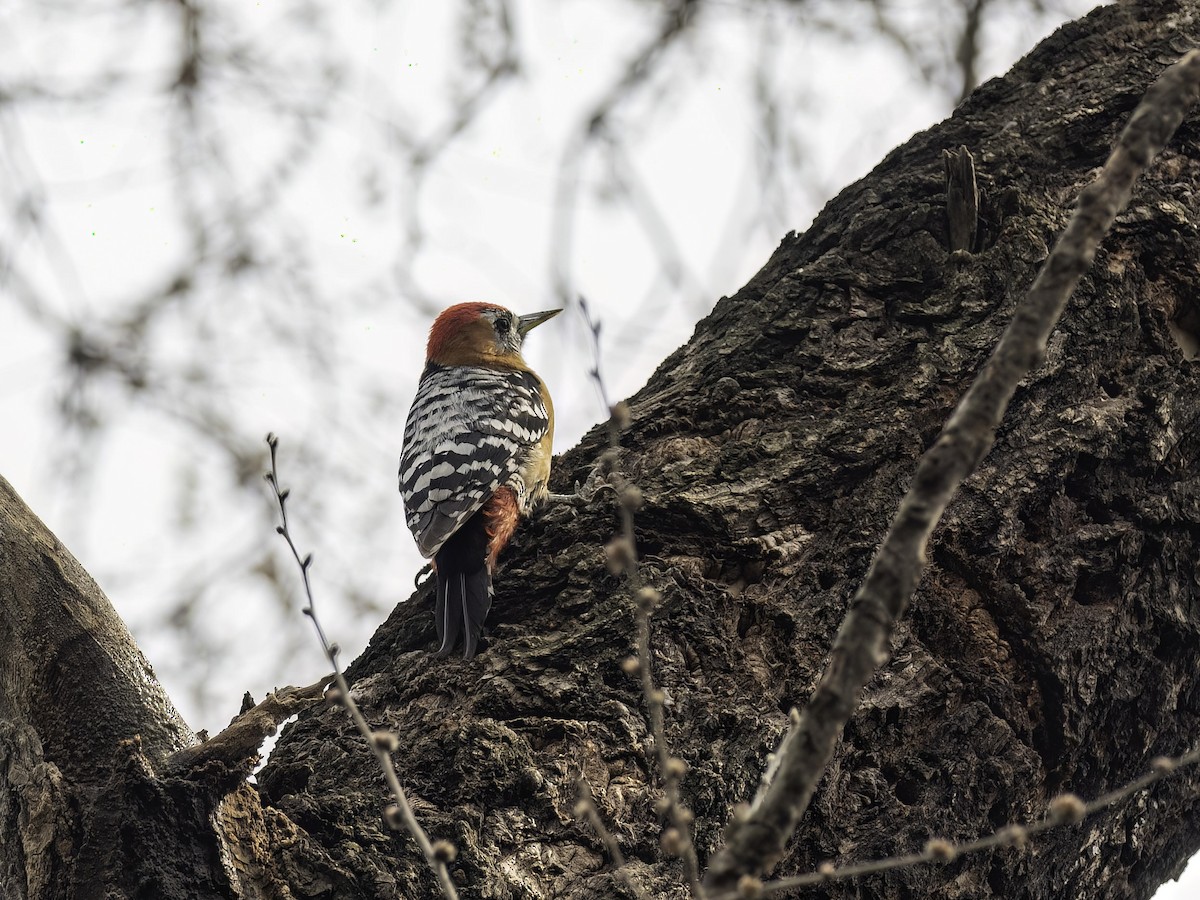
708 50 1200 888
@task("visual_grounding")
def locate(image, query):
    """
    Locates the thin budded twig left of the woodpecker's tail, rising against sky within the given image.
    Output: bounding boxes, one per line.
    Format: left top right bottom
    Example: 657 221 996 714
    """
266 434 458 900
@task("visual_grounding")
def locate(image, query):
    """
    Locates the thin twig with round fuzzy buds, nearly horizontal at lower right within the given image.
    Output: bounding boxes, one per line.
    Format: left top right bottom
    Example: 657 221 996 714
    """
709 750 1200 900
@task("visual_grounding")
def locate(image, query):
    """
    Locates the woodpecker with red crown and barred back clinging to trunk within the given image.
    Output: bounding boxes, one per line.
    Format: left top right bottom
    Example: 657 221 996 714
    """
400 304 562 659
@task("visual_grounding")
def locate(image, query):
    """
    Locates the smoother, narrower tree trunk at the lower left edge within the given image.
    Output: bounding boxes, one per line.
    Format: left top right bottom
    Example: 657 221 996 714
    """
0 479 245 900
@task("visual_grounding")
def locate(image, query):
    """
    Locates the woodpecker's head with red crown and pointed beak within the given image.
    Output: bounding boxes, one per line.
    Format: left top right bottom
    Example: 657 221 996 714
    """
425 304 562 368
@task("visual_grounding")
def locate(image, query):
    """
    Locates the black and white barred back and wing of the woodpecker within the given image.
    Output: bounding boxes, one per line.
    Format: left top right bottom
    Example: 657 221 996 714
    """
400 365 550 559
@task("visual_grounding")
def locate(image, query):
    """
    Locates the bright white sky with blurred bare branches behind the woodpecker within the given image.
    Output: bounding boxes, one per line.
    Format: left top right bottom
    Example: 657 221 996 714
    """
0 0 1091 728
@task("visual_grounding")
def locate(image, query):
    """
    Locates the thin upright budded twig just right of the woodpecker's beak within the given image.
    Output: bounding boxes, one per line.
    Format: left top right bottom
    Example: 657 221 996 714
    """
580 298 706 898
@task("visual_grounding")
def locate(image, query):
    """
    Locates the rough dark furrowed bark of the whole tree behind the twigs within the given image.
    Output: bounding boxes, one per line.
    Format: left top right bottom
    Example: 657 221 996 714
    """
0 0 1200 899
